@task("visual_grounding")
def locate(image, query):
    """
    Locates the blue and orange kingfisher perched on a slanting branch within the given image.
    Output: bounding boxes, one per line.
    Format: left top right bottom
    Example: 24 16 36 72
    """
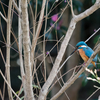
71 41 97 66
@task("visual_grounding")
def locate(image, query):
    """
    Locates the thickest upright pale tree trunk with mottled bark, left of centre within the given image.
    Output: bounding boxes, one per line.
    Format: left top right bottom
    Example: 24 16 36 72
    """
21 0 34 100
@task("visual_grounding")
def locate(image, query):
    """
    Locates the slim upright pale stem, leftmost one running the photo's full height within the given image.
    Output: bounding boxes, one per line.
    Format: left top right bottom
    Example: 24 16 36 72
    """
5 0 13 100
